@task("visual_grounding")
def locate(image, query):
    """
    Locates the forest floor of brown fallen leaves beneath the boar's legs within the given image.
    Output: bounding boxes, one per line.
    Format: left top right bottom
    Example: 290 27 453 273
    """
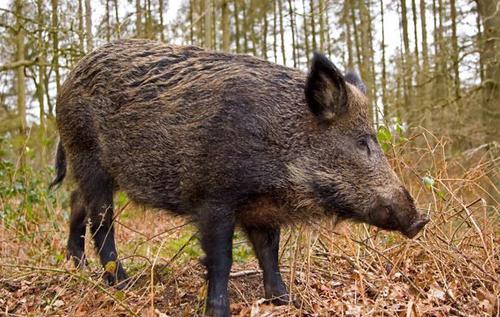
0 208 498 316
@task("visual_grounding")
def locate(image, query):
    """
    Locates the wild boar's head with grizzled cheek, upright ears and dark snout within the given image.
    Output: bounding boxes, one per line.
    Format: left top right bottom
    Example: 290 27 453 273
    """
289 54 429 238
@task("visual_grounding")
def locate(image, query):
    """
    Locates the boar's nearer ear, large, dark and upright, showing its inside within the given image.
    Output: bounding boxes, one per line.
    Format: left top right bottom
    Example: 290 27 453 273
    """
305 53 347 122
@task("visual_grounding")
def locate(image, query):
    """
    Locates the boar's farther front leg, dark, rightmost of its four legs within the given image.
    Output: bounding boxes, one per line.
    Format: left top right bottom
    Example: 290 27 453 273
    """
245 226 289 305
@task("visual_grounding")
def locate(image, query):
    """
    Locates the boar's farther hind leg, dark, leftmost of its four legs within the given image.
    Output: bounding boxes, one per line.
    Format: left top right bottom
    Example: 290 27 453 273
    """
68 190 87 268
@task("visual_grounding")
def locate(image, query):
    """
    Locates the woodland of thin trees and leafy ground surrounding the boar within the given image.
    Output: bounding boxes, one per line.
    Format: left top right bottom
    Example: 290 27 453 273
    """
0 0 500 317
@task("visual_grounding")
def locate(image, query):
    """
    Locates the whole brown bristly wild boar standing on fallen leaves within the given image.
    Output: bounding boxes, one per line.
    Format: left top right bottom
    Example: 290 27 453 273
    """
52 40 428 316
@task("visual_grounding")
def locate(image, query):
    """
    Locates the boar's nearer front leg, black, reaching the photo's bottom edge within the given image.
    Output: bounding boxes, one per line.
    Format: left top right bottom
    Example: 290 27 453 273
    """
198 206 235 317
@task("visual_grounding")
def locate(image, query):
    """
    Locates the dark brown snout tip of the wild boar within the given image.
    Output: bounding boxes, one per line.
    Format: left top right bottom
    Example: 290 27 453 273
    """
370 187 429 239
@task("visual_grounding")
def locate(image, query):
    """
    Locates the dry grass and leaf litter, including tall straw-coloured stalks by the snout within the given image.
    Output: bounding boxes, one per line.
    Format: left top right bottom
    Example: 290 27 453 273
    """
0 130 500 316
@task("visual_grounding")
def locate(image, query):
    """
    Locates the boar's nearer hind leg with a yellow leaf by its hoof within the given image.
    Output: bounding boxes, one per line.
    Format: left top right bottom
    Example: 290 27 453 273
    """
86 169 127 288
